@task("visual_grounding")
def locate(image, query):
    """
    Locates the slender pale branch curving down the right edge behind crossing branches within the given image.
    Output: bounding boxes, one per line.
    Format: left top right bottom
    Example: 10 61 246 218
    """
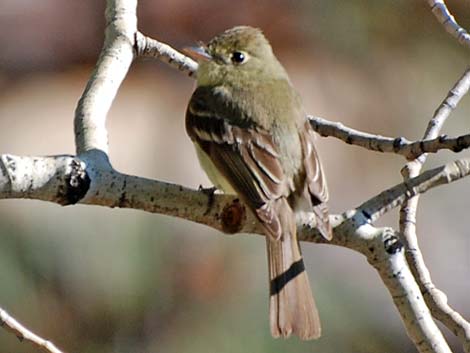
400 69 470 353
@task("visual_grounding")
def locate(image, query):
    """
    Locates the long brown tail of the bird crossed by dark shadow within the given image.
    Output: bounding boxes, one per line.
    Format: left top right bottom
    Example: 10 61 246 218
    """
266 198 321 340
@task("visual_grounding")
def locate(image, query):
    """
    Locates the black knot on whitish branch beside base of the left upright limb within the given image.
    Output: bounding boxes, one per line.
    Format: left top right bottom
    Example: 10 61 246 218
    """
57 158 91 206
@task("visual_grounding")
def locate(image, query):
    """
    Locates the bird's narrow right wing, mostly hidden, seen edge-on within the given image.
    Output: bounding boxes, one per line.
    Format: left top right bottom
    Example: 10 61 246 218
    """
300 121 332 240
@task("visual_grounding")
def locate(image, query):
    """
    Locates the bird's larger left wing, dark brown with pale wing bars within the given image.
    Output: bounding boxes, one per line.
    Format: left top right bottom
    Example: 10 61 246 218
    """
186 88 288 239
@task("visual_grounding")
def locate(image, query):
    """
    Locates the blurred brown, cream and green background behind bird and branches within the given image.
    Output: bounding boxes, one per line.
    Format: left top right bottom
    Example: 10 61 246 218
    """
0 0 470 353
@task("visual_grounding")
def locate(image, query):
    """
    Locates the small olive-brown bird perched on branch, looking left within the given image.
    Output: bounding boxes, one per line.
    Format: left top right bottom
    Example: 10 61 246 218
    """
186 26 332 340
